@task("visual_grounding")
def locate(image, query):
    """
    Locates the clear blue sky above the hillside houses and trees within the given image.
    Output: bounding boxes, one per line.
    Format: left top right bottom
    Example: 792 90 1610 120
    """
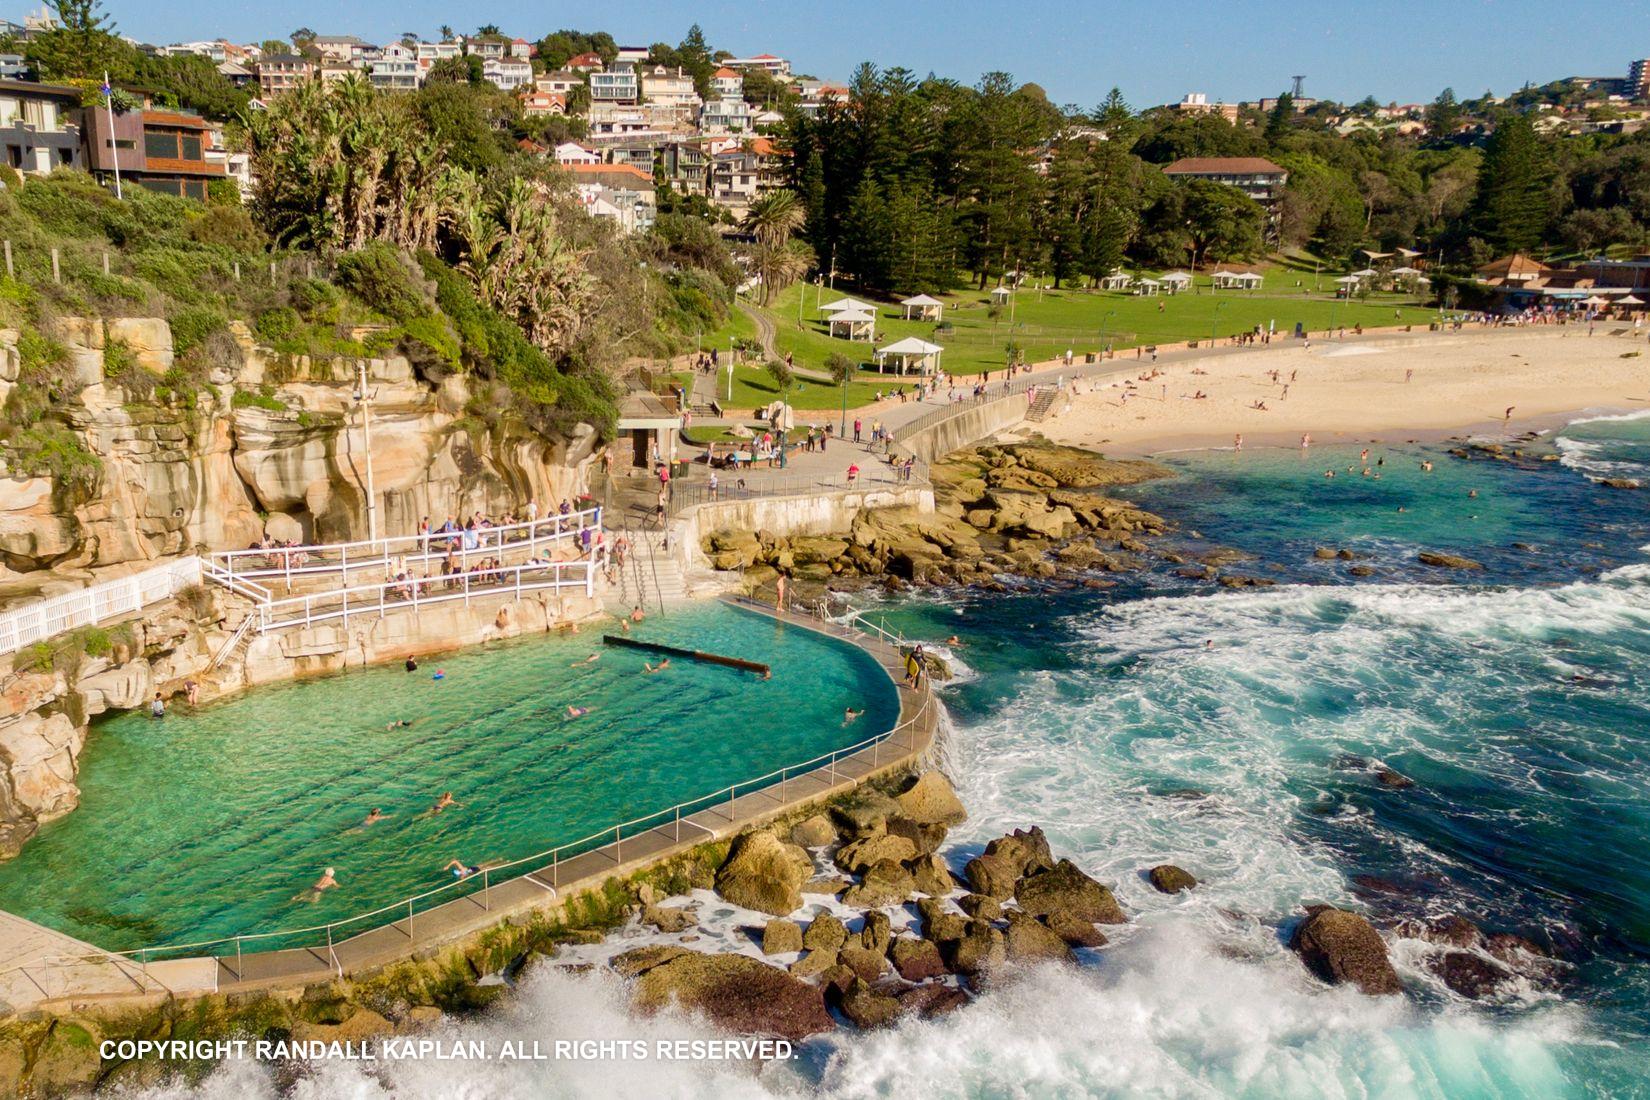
93 0 1623 107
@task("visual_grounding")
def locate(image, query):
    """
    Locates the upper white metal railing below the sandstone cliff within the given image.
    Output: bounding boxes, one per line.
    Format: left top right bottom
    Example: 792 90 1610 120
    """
208 506 602 589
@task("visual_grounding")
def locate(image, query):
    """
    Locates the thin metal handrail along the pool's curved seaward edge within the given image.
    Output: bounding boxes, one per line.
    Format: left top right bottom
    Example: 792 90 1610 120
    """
56 607 936 961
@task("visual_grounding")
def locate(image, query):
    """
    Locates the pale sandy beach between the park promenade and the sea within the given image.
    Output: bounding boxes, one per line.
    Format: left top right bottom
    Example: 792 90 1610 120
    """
1036 327 1650 455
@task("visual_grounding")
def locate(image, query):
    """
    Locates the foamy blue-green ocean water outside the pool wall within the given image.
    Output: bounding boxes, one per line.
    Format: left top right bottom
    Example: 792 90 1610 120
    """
128 421 1650 1098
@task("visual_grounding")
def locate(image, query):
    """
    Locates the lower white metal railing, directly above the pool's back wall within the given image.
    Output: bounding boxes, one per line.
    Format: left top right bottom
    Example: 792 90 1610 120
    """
257 551 606 632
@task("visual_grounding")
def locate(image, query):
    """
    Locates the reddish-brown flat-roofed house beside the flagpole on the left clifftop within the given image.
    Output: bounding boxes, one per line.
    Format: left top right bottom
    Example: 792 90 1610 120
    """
86 109 228 201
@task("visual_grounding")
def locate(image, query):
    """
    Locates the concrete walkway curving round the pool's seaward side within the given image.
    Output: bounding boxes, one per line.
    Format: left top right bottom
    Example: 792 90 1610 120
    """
0 599 939 1016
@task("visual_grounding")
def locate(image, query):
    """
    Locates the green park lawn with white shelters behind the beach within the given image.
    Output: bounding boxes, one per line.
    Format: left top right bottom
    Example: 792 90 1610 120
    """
705 267 1437 409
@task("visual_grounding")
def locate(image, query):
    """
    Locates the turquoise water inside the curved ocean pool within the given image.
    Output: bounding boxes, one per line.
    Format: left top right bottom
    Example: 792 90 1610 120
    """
0 605 899 950
